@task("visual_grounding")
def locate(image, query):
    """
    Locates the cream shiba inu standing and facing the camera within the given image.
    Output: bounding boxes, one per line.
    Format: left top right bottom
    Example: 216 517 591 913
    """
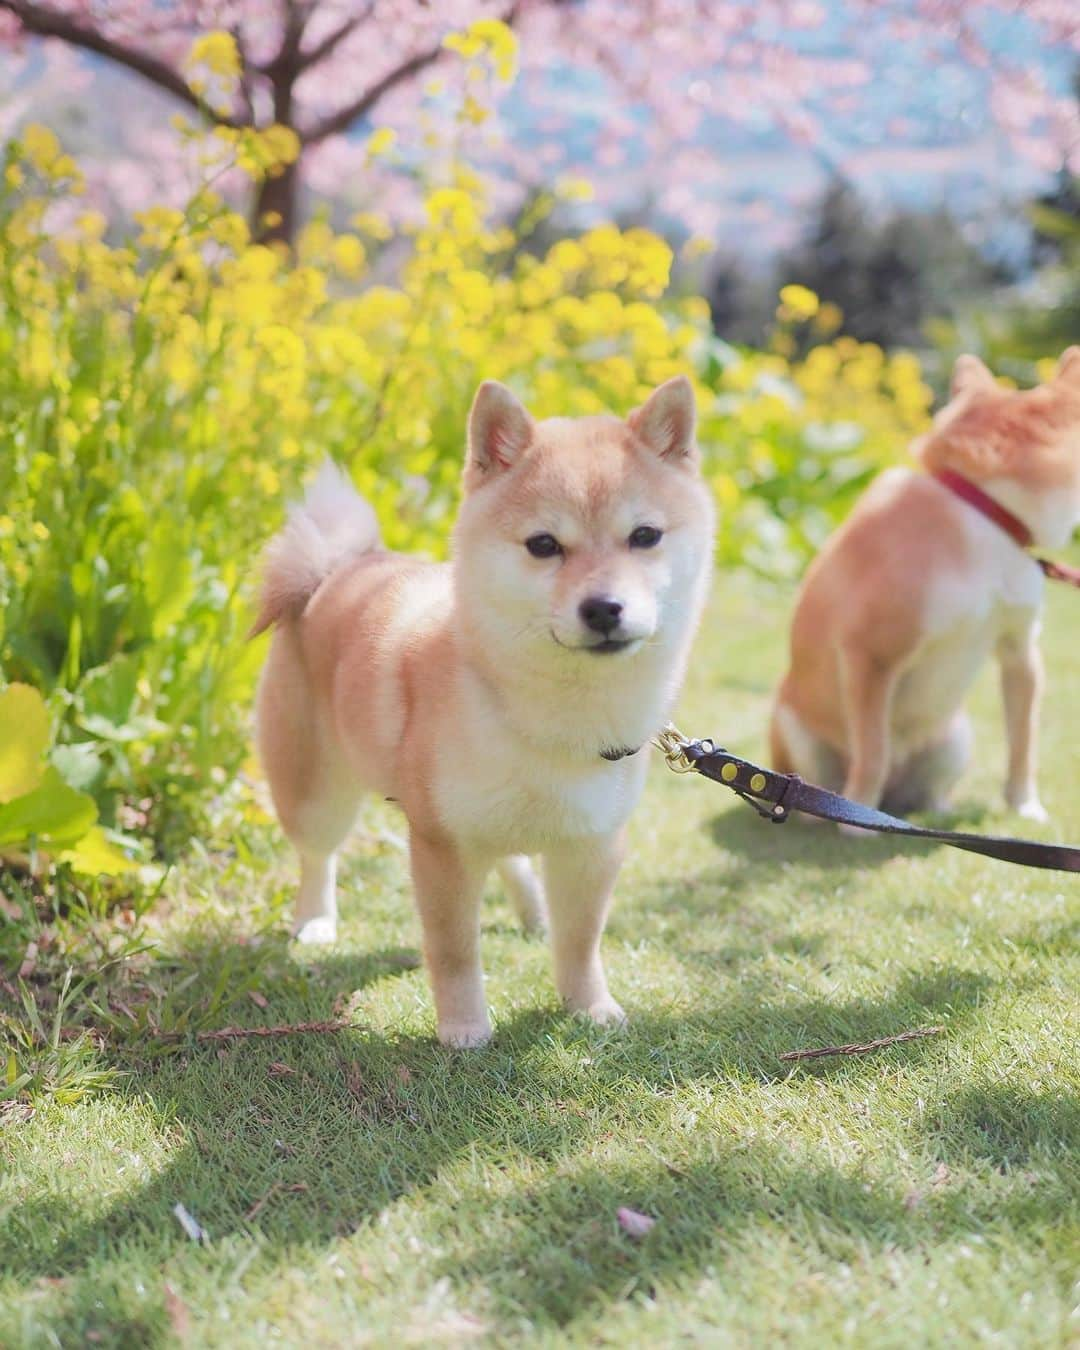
254 377 713 1046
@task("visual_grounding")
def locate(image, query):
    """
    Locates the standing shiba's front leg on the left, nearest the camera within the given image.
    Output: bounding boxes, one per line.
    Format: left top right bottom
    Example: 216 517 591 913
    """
409 832 491 1049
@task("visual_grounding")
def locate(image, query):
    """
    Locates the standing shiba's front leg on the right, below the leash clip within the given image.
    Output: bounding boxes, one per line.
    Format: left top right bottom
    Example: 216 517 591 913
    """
544 830 626 1025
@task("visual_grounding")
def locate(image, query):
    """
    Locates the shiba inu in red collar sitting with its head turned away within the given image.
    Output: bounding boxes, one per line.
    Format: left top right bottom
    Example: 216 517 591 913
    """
772 347 1080 819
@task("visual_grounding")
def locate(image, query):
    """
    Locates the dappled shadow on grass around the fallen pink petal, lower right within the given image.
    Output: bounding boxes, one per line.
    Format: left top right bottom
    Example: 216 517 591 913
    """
446 1087 1080 1327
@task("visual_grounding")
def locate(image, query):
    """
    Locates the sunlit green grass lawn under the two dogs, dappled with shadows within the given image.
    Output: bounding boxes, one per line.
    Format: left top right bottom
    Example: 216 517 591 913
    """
0 579 1080 1347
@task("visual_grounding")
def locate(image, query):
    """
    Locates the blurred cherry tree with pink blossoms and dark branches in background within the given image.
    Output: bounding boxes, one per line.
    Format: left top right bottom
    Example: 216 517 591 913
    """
0 0 1080 239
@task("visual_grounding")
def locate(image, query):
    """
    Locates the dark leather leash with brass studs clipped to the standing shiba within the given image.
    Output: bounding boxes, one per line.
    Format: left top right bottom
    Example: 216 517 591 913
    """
653 724 1080 872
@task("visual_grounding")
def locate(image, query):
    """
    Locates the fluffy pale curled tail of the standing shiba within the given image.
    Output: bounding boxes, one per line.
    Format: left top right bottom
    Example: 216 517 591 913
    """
248 459 382 637
